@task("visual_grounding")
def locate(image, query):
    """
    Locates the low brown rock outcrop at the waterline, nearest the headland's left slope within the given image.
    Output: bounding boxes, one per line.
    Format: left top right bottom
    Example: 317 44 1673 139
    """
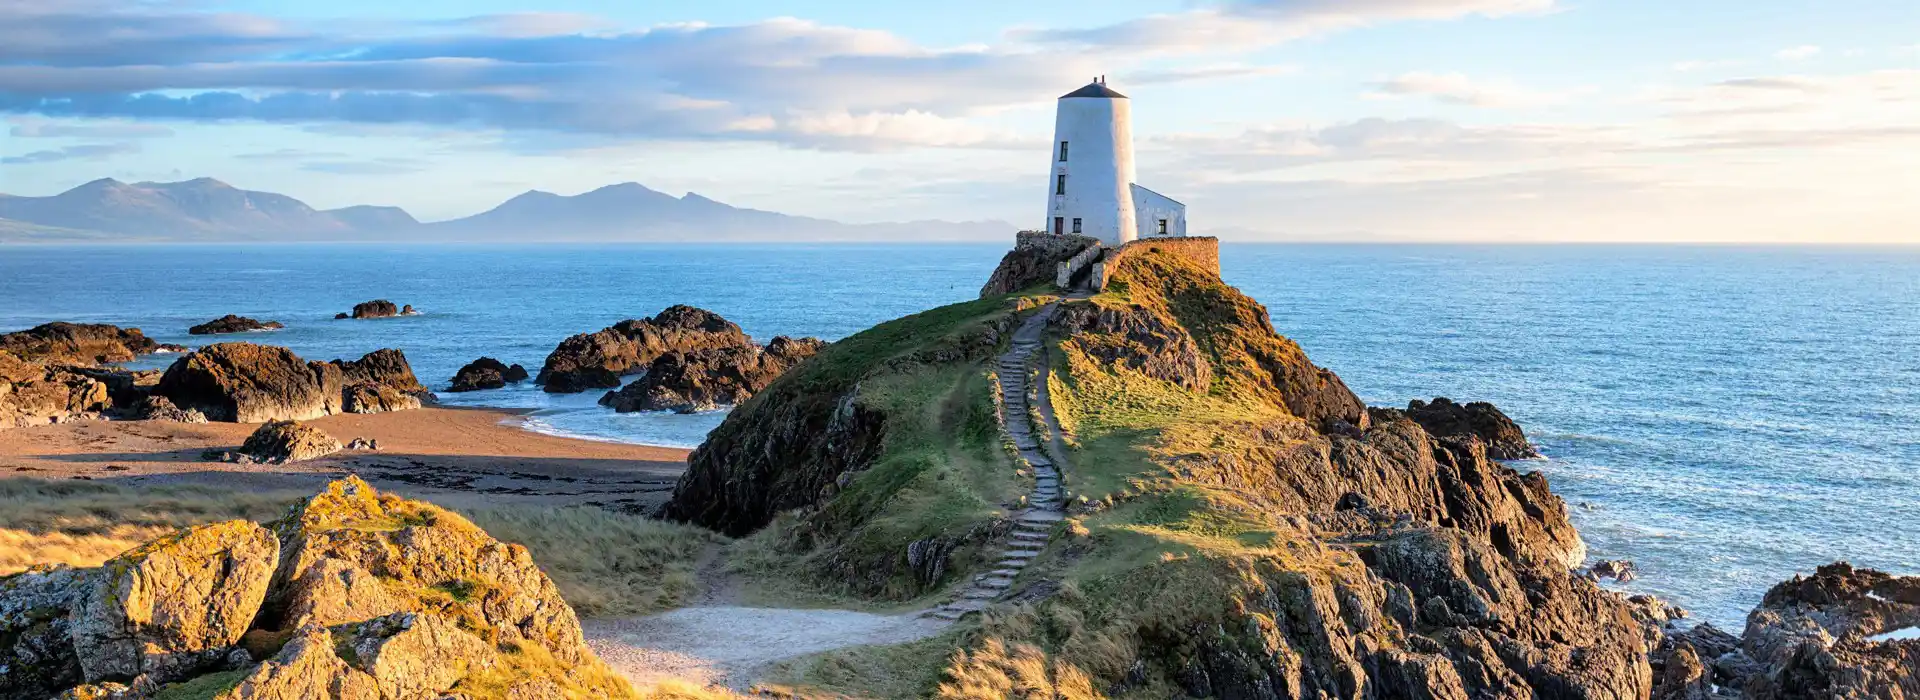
599 336 826 412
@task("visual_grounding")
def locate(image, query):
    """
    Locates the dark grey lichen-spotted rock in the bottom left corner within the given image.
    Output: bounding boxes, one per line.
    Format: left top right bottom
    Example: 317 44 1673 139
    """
0 566 100 700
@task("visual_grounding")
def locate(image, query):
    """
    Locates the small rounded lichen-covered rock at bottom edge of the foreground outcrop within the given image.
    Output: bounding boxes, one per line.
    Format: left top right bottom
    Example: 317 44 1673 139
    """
348 612 499 700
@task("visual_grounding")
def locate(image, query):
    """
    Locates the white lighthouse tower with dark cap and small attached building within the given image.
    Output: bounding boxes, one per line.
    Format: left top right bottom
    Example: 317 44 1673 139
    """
1044 79 1187 245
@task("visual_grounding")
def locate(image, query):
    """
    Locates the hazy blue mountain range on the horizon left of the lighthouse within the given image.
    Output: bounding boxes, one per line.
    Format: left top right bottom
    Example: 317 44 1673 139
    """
0 178 1014 244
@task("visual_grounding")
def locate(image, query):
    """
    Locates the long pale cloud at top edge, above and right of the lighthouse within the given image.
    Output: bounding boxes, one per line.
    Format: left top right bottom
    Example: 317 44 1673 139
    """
1021 0 1555 52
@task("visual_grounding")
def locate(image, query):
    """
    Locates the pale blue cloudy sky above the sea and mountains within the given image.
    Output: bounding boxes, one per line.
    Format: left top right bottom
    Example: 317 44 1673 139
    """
0 0 1920 244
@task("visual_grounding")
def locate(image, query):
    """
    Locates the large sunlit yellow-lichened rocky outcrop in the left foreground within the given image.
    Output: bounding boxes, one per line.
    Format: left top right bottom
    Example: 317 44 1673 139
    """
0 478 634 700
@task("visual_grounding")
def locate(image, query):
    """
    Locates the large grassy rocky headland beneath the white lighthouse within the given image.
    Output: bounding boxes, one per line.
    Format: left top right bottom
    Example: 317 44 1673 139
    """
664 247 1920 700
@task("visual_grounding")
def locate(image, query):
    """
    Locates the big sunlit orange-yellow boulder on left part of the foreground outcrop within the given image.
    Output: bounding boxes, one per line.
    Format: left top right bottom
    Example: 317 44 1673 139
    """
71 520 280 681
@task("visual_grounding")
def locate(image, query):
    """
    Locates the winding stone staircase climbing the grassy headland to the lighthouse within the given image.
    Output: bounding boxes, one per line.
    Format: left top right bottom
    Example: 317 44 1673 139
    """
927 305 1066 619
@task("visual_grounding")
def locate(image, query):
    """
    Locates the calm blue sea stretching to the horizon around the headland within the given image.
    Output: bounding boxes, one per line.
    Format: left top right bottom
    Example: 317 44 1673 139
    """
0 242 1920 629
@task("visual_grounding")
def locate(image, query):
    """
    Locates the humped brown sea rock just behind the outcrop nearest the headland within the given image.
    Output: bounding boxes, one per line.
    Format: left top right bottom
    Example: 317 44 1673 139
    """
536 305 753 393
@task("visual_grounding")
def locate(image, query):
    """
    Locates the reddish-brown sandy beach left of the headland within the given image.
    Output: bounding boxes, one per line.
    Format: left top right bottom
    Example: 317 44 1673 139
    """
0 407 687 512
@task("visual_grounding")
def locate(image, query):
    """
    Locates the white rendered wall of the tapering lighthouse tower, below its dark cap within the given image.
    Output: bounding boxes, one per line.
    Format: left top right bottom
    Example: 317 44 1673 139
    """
1044 98 1139 245
